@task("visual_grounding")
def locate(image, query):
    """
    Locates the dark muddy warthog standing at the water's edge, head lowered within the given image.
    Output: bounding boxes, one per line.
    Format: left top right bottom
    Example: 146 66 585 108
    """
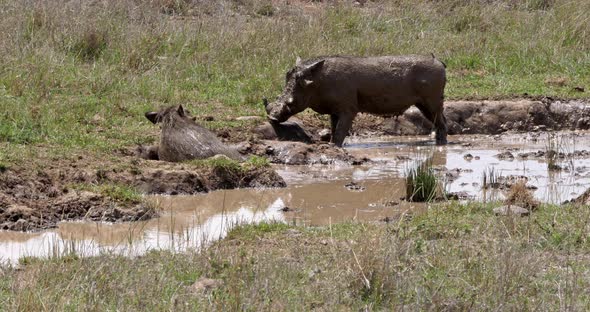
264 55 447 146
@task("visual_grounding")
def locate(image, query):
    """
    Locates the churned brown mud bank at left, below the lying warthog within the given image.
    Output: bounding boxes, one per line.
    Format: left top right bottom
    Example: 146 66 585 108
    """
0 157 285 231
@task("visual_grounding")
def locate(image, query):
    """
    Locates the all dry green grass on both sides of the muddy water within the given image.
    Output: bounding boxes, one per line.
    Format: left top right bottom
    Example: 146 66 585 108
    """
0 0 590 311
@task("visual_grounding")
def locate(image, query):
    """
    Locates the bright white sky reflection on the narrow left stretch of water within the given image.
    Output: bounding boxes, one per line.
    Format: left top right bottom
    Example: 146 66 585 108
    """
0 201 284 263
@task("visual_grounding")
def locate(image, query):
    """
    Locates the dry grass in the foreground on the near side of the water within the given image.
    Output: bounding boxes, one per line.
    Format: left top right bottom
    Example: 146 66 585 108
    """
0 203 590 311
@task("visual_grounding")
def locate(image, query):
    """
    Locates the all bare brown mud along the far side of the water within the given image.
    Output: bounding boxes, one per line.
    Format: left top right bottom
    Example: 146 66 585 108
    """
0 98 590 231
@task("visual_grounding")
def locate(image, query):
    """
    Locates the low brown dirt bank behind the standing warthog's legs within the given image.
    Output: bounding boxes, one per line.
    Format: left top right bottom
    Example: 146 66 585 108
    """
221 98 590 142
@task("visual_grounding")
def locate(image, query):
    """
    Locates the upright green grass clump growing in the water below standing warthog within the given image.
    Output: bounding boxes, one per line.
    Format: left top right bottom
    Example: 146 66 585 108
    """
406 159 440 202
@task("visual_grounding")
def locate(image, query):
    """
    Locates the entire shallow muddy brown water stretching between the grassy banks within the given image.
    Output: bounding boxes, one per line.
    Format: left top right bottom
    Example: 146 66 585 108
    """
0 132 590 262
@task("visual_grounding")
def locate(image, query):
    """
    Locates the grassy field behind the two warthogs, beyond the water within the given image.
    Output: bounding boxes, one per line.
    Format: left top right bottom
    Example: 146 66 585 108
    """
0 0 590 162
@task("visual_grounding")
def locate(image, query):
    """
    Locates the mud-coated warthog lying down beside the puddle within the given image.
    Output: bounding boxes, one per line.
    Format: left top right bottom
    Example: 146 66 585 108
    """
138 105 243 162
